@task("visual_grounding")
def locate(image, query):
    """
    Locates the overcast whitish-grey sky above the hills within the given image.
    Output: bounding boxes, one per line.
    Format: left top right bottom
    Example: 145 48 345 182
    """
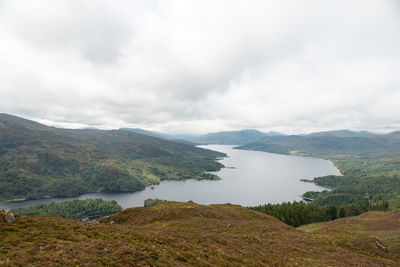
0 0 400 133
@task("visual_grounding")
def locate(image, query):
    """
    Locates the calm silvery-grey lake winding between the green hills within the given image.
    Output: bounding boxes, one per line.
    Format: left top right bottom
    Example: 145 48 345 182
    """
0 145 339 209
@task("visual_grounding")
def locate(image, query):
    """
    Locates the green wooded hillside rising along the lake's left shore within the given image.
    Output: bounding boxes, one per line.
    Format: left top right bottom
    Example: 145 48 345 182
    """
0 114 224 201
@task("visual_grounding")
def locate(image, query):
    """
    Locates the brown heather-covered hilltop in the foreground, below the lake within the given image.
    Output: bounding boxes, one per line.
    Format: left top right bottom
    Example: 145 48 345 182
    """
0 202 400 266
